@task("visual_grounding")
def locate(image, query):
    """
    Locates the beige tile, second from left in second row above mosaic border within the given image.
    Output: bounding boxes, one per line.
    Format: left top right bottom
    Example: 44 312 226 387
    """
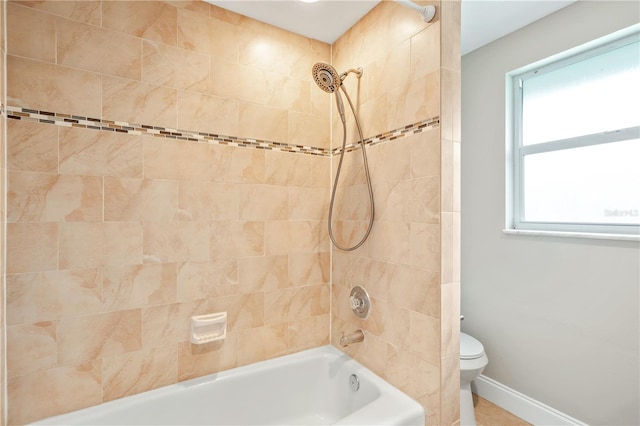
56 18 142 80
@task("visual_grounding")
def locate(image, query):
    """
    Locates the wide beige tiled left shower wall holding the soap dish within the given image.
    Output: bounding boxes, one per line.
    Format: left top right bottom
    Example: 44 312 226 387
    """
3 1 331 424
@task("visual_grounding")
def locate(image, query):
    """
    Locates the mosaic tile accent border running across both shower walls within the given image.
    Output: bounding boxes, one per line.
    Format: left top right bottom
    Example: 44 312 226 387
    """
2 105 440 157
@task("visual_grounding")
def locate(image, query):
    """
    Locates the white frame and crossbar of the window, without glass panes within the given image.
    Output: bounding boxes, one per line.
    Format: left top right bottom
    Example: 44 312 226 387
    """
506 25 640 236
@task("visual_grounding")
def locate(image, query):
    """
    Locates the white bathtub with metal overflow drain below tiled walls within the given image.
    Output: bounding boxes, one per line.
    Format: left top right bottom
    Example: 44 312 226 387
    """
34 346 424 426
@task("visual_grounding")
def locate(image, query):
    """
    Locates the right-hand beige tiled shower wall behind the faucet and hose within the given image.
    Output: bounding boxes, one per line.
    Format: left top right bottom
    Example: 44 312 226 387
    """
331 1 460 425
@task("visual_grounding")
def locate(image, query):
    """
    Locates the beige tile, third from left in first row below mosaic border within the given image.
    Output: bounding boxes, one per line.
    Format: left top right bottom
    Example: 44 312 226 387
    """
143 136 209 181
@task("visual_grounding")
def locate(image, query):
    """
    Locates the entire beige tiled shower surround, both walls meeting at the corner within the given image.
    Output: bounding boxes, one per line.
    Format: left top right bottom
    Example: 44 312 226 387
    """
1 1 460 424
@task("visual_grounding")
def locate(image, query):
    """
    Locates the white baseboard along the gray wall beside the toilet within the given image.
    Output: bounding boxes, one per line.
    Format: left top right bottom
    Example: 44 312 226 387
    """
471 375 587 426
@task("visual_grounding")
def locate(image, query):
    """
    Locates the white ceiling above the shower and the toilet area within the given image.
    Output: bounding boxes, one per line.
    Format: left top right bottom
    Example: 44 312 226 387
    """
207 0 575 55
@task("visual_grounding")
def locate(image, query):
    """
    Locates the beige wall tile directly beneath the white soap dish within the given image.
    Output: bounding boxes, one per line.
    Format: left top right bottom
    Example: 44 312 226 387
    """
178 333 238 381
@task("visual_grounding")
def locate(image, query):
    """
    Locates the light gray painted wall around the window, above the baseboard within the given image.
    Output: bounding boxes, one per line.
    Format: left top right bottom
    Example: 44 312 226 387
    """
461 1 640 425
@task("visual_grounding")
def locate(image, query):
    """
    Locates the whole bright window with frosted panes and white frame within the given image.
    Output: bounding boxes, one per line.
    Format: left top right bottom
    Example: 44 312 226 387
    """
507 27 640 235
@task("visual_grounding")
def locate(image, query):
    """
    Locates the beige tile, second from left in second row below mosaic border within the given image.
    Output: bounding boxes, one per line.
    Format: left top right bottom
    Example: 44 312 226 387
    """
104 177 178 222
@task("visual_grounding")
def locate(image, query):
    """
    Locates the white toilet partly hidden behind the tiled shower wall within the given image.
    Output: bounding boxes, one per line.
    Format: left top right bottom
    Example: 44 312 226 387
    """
460 333 489 426
